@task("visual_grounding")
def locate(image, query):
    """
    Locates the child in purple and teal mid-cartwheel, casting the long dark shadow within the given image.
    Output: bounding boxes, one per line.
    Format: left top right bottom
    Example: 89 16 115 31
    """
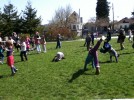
84 36 106 75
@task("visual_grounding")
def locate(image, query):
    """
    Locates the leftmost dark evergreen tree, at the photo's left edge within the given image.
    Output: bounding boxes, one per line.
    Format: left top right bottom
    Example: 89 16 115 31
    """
2 3 19 35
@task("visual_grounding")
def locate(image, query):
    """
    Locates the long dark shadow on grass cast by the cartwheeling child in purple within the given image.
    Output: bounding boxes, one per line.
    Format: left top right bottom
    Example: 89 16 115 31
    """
68 69 95 83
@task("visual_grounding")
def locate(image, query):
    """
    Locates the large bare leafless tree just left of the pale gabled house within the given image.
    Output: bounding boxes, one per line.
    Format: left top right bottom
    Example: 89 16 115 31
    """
49 5 72 35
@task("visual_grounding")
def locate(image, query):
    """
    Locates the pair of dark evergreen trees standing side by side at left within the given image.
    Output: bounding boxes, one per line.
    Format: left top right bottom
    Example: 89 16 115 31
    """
0 2 41 36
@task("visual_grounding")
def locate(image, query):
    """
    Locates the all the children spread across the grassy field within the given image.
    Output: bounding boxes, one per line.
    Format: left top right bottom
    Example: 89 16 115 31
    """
0 29 134 75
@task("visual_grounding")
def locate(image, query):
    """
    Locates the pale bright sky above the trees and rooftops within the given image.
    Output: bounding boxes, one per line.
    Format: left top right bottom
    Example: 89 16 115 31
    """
0 0 134 24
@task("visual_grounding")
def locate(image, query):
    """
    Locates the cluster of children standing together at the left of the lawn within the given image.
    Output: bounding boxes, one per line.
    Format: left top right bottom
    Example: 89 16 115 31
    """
0 32 46 75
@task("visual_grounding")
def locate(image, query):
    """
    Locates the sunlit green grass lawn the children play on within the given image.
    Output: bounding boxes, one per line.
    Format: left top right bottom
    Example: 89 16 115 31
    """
0 39 134 100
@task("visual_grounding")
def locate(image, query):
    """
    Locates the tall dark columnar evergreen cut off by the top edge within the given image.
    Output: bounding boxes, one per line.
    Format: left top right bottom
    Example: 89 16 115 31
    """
96 0 109 19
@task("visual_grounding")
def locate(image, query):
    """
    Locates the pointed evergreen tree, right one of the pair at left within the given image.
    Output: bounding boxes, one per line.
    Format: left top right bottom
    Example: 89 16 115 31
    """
23 2 41 35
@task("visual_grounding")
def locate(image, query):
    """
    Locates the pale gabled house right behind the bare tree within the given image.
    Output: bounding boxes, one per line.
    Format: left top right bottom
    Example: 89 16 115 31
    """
69 10 83 36
